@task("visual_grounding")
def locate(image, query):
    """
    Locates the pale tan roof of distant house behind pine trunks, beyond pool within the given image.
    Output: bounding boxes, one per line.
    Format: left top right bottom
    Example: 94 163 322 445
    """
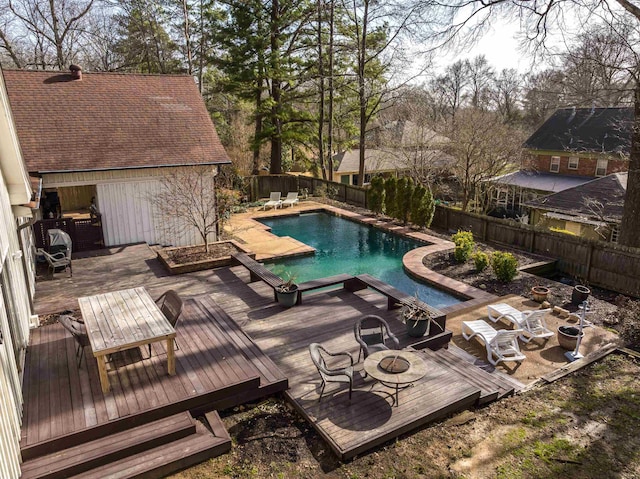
333 148 454 173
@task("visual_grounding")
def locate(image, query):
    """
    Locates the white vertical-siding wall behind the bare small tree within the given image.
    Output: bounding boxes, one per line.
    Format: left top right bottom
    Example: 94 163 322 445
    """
97 179 202 246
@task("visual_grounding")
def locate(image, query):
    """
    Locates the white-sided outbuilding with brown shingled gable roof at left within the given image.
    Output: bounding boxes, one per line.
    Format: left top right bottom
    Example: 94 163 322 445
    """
4 68 230 251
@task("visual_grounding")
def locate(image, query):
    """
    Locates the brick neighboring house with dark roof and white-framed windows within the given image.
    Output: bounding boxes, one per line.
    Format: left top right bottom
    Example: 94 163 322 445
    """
488 107 633 218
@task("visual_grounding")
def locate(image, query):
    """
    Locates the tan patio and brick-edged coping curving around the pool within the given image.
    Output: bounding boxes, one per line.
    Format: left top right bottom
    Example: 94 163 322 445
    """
225 201 498 314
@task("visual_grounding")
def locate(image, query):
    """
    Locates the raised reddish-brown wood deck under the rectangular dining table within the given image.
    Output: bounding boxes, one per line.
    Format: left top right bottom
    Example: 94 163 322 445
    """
21 298 288 460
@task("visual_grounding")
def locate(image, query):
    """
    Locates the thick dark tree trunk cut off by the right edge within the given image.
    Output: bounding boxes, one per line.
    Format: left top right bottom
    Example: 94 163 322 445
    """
618 83 640 248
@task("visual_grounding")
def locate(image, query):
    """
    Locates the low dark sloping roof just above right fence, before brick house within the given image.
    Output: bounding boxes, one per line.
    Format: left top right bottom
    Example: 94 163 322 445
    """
525 173 628 222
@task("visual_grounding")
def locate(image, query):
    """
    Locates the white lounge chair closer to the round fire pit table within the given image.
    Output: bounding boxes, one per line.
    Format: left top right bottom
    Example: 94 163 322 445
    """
462 319 527 366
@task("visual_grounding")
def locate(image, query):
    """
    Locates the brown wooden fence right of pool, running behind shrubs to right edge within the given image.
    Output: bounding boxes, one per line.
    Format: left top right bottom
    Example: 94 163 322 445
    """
431 206 640 297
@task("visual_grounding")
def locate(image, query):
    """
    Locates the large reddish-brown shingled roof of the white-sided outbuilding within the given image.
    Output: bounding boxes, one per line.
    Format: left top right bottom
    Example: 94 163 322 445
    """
4 70 230 173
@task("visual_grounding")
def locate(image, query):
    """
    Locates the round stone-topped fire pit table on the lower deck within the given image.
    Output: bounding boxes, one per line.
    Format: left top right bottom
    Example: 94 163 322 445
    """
363 350 427 406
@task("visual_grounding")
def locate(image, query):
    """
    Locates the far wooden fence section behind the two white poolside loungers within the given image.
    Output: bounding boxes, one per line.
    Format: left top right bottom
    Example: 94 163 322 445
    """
250 175 367 208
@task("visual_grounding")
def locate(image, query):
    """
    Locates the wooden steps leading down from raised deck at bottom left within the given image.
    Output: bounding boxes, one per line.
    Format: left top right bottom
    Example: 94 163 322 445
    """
22 412 231 479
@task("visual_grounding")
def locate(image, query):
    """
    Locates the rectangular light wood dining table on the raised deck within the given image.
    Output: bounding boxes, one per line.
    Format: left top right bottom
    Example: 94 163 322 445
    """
78 287 176 393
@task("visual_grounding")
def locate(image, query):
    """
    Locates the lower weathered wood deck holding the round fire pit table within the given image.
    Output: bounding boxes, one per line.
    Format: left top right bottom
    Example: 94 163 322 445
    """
210 283 513 459
